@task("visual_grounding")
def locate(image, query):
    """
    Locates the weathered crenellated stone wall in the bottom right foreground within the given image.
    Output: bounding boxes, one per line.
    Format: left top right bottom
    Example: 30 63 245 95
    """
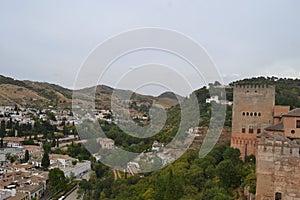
256 135 300 200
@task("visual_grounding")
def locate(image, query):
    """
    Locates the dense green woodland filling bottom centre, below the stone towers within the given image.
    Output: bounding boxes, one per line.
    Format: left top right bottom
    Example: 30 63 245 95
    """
79 144 255 200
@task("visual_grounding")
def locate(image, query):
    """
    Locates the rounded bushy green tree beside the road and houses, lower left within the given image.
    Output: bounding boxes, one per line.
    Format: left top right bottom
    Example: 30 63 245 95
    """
49 168 67 192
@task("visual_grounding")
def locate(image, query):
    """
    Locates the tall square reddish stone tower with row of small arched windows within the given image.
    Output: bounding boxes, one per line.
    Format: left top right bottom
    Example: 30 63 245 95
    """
231 85 275 159
